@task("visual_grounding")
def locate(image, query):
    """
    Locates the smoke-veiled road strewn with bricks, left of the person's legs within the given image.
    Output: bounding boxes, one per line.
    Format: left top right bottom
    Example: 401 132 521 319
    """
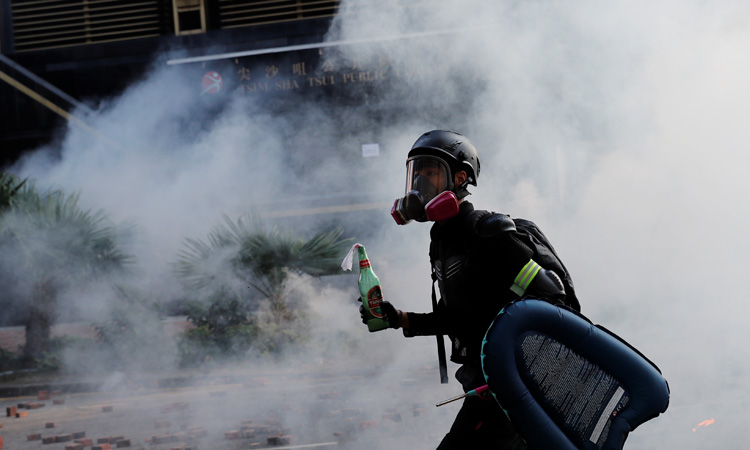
0 369 458 450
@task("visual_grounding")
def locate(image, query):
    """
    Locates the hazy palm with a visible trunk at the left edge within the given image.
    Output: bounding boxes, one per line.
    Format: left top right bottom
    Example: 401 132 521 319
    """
0 182 131 365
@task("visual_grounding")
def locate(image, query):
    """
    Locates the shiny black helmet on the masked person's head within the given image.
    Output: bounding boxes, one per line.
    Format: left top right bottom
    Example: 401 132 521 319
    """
407 130 479 198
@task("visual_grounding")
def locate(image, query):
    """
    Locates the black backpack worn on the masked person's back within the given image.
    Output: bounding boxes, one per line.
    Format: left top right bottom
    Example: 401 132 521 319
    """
467 210 581 311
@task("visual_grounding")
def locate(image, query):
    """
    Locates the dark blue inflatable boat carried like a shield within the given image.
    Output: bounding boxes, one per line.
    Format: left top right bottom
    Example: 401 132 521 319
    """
482 299 669 450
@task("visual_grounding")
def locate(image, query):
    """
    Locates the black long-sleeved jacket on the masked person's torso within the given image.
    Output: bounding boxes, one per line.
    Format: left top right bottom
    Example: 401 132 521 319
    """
406 201 548 388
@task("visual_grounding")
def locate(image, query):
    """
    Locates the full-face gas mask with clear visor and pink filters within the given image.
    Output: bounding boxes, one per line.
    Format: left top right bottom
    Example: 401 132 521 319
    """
391 155 458 225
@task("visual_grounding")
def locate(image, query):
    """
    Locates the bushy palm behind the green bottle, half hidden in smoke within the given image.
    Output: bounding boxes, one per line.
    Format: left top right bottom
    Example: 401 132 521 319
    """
176 216 349 323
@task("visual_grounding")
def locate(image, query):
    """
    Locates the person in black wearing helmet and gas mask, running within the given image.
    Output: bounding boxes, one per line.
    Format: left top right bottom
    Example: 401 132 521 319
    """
370 130 576 450
